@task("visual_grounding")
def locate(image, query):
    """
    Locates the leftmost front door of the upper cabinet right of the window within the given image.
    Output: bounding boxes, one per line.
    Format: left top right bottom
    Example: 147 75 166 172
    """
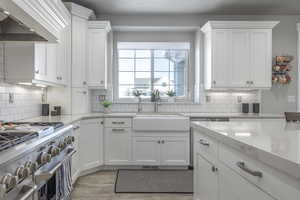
212 30 231 88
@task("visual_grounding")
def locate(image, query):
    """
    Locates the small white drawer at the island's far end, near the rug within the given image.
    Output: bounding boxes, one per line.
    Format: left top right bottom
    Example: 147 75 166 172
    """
194 132 218 159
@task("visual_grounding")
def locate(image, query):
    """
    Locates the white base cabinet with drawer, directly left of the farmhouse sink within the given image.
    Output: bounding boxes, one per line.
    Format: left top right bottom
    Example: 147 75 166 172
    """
104 118 132 165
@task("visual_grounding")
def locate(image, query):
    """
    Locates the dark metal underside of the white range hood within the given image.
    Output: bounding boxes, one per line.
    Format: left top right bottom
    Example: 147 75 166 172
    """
0 9 47 41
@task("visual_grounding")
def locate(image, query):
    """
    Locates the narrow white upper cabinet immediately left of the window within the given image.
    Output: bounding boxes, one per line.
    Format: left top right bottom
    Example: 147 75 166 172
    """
87 21 111 89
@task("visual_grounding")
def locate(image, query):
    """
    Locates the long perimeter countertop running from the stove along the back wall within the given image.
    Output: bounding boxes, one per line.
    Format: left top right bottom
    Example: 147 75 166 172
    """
21 112 284 124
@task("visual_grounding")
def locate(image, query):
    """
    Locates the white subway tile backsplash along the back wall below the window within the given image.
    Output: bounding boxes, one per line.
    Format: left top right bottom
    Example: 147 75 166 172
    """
91 90 260 113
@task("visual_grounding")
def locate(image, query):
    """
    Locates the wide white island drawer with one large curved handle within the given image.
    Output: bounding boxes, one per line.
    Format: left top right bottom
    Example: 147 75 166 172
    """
219 145 300 200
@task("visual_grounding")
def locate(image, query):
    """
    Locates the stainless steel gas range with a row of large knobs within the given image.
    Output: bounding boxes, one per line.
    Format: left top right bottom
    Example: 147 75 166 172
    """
0 122 76 200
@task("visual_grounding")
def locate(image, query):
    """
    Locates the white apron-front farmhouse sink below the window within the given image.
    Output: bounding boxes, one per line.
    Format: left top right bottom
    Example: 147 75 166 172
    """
133 113 190 132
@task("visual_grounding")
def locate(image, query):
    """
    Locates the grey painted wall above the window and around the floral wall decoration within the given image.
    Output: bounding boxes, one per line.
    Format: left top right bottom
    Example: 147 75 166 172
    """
98 15 300 113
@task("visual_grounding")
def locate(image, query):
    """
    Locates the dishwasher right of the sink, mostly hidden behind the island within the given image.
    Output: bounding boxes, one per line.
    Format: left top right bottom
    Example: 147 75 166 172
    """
189 117 230 169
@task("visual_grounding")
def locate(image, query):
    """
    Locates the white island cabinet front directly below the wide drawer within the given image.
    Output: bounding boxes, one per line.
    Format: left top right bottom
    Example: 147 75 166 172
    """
218 165 273 200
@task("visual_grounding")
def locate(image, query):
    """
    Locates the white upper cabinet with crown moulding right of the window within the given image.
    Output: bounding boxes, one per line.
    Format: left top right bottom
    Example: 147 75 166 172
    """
201 21 279 90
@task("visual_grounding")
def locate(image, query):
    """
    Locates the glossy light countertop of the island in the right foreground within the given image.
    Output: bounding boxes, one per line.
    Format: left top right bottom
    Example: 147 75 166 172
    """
191 119 300 178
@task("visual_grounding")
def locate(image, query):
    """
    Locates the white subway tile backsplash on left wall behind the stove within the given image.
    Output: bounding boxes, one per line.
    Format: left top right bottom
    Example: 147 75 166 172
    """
0 83 43 121
